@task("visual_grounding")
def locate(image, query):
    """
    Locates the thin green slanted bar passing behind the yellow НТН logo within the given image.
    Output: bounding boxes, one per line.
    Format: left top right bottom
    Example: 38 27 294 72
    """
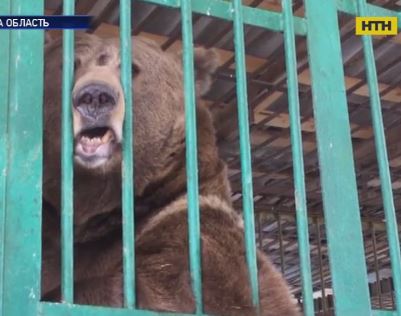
357 0 401 316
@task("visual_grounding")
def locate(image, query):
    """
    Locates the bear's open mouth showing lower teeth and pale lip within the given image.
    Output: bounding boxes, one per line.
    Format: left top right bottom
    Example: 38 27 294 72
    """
75 126 116 165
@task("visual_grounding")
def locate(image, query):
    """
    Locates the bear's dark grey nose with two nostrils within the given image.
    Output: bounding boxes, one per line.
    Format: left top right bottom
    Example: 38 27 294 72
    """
73 83 117 120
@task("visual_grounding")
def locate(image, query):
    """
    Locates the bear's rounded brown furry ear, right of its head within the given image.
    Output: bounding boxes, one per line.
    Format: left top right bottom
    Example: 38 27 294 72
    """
194 47 219 96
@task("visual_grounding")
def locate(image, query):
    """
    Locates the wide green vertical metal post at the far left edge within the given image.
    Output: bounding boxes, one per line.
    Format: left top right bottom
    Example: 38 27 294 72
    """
0 0 44 316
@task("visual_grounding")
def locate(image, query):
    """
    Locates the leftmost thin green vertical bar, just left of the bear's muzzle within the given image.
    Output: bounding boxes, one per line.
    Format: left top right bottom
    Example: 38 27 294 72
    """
61 0 75 303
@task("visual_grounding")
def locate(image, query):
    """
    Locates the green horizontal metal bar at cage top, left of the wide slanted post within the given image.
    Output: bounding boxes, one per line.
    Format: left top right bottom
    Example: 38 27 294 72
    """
141 0 306 35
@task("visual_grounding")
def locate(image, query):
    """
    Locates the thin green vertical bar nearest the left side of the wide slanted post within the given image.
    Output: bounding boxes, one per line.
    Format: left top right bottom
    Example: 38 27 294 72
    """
282 0 314 316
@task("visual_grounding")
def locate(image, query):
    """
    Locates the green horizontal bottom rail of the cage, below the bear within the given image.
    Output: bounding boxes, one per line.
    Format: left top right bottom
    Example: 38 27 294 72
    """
38 302 207 316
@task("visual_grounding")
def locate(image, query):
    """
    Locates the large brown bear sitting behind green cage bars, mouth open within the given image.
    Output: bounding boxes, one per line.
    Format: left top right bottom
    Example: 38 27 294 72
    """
42 35 299 316
